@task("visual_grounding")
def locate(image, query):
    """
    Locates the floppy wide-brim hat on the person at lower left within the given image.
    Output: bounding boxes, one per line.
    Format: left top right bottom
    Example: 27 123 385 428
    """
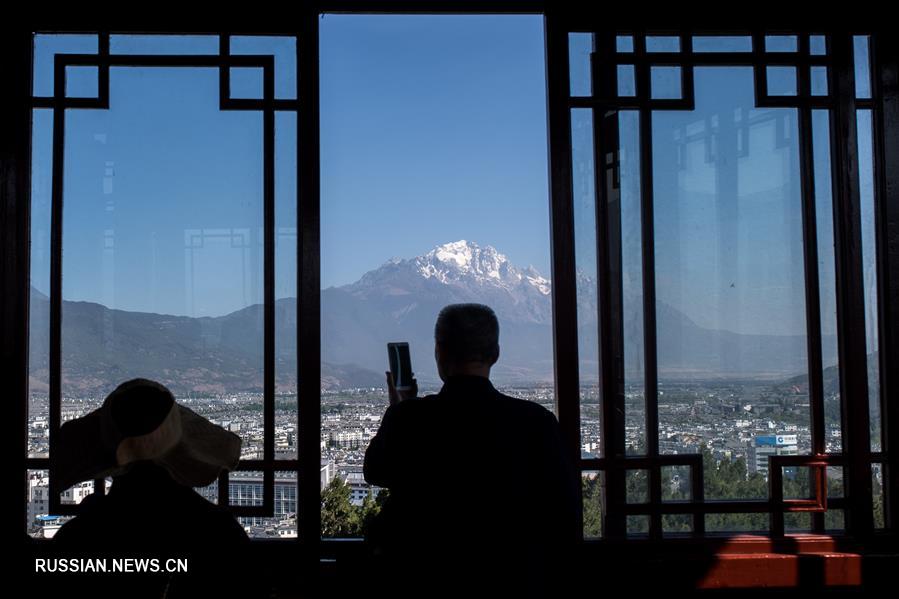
51 379 241 489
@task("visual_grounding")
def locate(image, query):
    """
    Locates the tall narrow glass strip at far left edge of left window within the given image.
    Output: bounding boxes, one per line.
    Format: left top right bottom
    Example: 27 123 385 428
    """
28 110 53 458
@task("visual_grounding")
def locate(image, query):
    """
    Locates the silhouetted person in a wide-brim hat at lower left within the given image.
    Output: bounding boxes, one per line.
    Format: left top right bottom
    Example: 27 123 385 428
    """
53 379 256 597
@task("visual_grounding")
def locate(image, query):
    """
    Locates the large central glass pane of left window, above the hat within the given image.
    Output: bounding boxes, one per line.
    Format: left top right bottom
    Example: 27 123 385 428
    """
62 68 263 457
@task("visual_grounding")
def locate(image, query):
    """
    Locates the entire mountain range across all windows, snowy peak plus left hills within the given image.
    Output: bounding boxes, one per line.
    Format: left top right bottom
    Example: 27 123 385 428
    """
29 241 836 394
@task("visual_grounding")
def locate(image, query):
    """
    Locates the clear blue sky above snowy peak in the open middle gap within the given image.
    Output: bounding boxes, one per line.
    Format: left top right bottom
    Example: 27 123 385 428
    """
321 15 549 286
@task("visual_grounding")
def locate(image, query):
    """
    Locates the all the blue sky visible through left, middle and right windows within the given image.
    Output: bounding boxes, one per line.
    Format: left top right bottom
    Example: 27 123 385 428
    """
33 25 874 342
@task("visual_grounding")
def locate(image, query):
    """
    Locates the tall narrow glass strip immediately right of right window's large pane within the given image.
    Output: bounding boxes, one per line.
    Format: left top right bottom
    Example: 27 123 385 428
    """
816 110 843 453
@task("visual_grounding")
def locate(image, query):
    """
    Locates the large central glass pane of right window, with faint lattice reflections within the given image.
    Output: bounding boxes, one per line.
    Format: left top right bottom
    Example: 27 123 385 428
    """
653 67 810 499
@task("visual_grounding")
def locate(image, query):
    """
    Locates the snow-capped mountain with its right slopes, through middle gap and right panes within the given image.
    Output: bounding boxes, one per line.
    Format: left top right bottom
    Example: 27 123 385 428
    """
322 241 832 382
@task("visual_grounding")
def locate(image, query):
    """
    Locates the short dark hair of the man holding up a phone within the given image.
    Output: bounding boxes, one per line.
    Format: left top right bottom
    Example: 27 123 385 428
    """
434 304 499 364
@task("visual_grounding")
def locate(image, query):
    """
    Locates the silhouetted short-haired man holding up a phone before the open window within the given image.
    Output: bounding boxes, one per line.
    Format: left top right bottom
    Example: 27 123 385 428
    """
365 304 581 597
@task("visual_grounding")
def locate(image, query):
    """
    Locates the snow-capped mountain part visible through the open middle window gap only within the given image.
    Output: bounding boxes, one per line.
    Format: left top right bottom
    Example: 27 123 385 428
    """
322 240 552 381
